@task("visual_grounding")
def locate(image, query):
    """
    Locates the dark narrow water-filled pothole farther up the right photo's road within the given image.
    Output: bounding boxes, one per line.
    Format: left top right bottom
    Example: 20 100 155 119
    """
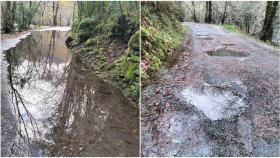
206 48 249 57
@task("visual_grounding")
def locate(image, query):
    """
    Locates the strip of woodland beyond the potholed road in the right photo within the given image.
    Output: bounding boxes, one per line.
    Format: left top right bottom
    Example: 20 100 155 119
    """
185 1 280 42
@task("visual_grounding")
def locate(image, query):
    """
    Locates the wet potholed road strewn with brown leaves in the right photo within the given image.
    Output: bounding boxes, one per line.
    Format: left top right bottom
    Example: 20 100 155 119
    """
141 23 280 156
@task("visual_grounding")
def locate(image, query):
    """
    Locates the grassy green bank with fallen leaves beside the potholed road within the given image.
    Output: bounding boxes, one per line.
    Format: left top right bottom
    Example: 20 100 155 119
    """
141 2 184 80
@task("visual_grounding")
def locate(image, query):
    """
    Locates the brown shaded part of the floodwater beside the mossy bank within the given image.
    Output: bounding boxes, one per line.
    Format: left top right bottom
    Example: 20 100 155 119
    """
48 58 138 156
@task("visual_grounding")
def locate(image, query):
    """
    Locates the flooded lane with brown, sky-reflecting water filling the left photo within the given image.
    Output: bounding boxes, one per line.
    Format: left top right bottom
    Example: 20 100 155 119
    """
1 30 139 156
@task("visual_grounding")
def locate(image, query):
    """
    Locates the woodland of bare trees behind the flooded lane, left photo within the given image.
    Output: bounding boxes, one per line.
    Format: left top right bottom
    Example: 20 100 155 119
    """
1 1 74 33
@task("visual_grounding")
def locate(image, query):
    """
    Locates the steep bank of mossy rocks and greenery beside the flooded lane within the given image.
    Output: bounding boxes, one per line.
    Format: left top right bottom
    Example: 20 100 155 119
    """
66 1 140 102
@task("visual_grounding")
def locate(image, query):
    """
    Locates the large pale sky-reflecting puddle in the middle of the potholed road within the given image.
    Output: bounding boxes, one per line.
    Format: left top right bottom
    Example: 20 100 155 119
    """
181 85 245 120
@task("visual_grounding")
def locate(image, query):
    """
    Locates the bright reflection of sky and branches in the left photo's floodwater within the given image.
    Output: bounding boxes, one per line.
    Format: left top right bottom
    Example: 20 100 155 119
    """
6 31 71 143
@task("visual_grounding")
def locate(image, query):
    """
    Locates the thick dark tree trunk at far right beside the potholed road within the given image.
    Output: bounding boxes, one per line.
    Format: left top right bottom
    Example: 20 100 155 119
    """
260 1 278 41
